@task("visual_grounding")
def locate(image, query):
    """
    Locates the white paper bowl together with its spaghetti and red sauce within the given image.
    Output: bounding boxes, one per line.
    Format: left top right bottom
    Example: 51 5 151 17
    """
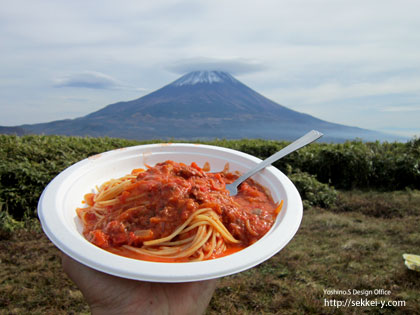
38 143 303 282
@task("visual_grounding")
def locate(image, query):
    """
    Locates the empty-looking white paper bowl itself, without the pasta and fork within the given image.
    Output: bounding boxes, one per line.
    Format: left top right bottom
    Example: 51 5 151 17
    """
38 144 303 282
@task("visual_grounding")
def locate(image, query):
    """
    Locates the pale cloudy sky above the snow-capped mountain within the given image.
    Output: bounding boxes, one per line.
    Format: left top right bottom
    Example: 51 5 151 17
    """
0 0 420 137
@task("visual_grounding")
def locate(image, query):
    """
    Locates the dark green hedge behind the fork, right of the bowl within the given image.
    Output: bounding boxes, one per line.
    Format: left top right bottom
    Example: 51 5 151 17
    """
209 139 420 190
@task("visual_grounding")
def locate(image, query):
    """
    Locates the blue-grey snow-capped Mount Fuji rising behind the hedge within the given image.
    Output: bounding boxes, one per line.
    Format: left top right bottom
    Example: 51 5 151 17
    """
2 71 401 142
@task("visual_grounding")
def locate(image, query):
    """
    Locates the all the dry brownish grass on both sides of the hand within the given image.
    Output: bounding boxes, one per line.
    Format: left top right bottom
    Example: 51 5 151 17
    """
0 191 420 314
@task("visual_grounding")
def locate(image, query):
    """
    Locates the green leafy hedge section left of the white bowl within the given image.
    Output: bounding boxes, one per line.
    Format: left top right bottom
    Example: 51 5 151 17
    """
0 135 144 219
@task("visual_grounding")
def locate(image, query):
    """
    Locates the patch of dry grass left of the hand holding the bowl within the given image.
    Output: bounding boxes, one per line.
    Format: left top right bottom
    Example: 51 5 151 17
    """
0 231 89 314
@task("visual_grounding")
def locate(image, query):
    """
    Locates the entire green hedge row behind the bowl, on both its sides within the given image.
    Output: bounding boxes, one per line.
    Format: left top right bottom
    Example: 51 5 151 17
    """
0 135 420 223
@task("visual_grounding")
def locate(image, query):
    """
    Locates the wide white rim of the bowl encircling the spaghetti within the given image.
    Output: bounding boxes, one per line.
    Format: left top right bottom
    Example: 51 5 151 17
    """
38 143 303 282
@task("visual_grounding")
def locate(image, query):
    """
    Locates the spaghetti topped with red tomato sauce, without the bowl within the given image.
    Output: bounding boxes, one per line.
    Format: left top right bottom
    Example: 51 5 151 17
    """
76 161 281 262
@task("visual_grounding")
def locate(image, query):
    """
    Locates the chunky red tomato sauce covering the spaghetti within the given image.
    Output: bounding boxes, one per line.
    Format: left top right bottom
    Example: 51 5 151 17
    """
77 161 281 261
